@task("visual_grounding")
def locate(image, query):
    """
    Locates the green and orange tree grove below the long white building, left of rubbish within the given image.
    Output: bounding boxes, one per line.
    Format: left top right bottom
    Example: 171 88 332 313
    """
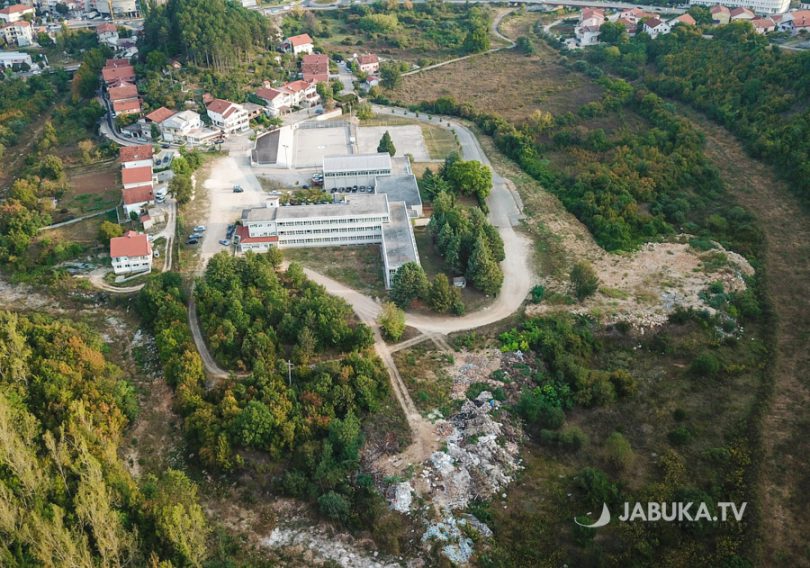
139 255 404 538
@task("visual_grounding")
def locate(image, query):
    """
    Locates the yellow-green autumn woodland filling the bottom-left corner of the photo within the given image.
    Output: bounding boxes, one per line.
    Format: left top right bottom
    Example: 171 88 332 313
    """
0 312 208 566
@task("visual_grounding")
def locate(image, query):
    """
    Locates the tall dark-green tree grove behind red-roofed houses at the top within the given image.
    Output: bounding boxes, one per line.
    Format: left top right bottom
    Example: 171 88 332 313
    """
140 0 271 70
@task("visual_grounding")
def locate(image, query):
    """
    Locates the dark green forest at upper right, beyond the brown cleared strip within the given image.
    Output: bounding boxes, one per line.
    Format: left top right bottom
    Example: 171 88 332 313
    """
585 22 810 209
